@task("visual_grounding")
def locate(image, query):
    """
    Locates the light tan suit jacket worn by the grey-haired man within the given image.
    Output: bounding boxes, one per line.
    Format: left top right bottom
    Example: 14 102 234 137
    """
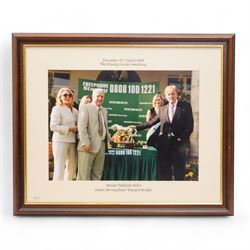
77 103 108 153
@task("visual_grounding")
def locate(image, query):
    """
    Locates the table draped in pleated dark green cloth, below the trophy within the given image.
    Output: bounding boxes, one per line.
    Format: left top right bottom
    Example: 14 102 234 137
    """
102 147 157 181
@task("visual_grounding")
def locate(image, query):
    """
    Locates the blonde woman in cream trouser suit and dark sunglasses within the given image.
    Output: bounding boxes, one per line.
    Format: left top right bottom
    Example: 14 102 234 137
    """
50 88 78 180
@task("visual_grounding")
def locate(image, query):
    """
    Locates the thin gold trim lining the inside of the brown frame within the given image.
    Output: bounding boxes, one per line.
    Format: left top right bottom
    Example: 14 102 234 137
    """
23 44 224 206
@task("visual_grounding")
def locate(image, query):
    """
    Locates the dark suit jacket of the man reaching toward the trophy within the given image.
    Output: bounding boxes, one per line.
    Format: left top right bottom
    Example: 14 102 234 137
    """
136 101 194 146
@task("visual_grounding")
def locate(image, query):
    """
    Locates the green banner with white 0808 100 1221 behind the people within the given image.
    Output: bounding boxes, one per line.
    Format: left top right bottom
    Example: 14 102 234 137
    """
78 79 160 142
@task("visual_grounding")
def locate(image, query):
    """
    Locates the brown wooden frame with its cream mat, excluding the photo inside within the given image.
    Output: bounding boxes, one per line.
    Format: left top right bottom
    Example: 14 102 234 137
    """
12 33 235 215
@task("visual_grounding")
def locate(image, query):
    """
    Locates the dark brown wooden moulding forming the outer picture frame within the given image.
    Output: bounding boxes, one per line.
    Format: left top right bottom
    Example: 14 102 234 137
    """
12 33 235 215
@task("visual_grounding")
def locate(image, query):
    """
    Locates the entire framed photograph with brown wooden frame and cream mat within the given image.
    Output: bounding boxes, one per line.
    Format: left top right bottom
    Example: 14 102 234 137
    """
12 33 235 215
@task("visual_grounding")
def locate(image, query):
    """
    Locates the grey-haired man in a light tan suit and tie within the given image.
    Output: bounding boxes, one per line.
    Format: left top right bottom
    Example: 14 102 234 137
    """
77 89 108 180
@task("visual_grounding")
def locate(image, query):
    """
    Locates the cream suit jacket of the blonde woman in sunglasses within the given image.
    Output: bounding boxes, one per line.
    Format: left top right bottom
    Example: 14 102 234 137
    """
50 106 78 143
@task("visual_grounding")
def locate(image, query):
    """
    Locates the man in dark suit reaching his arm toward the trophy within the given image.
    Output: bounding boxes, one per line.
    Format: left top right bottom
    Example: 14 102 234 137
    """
133 85 194 180
